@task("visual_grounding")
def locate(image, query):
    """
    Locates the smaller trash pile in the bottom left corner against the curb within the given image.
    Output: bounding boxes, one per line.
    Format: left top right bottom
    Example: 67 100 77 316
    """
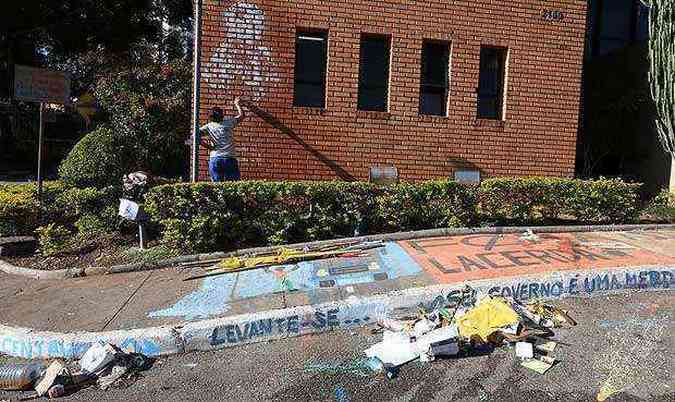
0 342 152 400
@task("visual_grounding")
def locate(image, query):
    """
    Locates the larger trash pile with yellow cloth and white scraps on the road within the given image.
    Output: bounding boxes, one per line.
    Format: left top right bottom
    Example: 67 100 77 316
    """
365 287 576 378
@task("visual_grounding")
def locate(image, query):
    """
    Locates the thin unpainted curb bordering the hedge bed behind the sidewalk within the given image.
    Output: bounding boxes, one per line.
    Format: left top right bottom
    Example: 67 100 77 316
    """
0 224 675 280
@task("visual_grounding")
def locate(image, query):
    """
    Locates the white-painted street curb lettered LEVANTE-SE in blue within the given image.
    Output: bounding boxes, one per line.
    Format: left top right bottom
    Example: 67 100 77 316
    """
0 266 675 359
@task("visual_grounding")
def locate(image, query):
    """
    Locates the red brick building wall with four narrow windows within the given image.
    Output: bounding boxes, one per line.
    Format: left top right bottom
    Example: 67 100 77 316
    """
200 0 586 180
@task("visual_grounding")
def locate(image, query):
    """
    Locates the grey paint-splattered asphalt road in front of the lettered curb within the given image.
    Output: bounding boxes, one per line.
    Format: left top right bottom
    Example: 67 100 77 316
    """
0 291 675 402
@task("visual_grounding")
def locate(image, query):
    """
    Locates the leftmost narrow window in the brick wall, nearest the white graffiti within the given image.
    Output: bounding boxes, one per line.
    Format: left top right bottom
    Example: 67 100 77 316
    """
293 31 328 108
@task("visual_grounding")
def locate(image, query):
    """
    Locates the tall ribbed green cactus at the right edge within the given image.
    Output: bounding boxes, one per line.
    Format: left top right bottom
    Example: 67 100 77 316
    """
644 0 675 158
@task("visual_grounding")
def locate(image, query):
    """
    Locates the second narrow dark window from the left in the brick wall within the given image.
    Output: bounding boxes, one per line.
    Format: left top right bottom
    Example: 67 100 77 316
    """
358 34 391 112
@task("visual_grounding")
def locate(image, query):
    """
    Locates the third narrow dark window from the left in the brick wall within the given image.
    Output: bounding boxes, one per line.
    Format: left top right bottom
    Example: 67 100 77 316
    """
420 41 450 116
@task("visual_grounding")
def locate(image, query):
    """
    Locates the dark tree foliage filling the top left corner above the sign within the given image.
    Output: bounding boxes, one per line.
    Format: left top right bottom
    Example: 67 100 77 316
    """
0 0 192 98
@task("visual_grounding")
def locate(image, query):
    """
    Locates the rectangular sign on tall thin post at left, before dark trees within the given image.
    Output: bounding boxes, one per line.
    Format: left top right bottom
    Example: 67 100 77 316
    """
14 65 70 217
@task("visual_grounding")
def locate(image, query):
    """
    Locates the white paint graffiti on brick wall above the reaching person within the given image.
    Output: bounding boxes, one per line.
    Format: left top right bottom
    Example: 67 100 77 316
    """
202 2 279 101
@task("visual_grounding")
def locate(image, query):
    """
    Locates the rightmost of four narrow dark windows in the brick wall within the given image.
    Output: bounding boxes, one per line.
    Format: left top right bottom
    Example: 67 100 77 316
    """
478 47 507 120
